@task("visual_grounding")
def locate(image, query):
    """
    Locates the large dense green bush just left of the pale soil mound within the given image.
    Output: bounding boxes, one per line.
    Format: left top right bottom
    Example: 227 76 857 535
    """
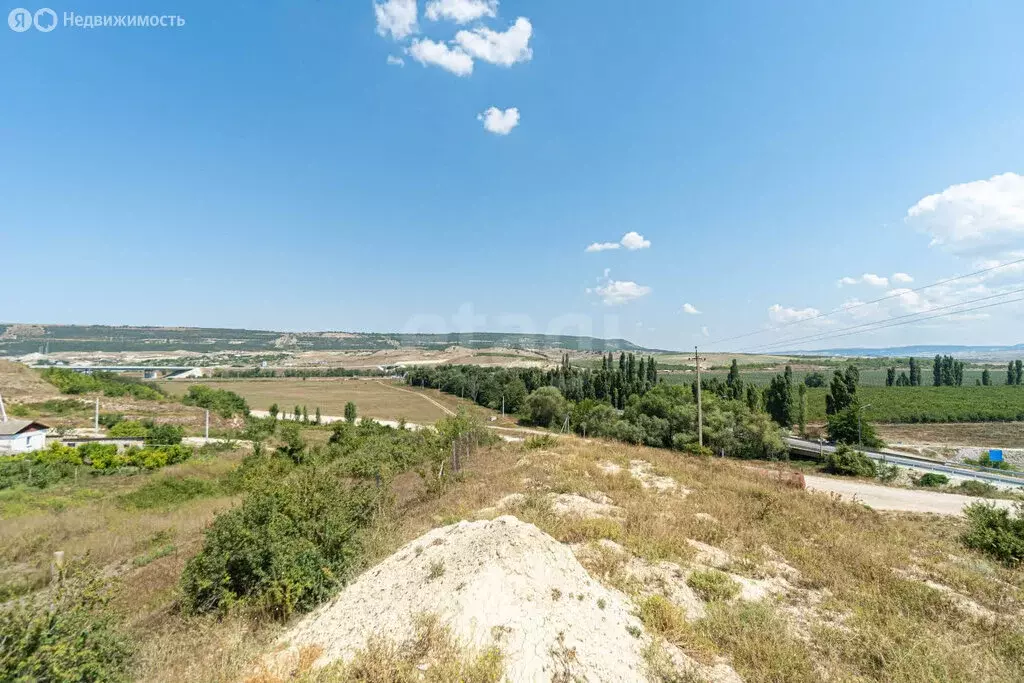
181 466 378 620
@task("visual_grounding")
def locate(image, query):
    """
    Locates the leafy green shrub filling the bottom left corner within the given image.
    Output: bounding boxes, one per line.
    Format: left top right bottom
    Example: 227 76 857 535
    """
0 570 131 683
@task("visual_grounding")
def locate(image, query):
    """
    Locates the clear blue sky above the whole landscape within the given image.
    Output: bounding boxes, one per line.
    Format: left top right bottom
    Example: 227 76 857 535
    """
0 0 1024 350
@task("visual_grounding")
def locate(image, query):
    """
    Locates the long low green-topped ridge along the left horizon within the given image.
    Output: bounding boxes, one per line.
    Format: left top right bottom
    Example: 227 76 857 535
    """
0 324 655 356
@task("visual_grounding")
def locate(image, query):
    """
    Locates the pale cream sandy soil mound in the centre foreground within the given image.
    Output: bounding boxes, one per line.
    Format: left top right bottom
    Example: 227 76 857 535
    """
276 516 731 681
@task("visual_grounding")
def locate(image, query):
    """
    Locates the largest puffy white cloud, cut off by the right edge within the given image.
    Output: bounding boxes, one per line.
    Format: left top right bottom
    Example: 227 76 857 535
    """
905 173 1024 254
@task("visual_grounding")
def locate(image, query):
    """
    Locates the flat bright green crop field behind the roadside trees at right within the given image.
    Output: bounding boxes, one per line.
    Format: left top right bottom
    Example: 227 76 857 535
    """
807 385 1024 423
